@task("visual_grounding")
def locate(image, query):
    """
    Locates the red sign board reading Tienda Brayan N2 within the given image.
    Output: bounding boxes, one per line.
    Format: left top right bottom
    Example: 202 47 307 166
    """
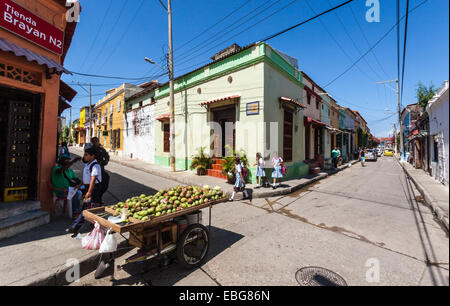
0 0 64 55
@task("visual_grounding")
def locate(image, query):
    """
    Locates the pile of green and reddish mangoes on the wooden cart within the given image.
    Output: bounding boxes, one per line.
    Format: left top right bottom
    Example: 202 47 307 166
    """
112 186 226 221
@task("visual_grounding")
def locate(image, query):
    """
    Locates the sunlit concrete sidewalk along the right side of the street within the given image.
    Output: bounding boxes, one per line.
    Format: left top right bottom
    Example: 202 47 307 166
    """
397 159 449 232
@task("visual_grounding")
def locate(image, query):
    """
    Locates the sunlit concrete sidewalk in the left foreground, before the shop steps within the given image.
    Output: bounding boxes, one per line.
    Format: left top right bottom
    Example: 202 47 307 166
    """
0 217 129 286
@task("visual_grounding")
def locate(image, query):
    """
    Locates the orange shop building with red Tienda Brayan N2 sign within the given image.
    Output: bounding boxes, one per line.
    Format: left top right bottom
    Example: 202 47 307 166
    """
0 0 77 215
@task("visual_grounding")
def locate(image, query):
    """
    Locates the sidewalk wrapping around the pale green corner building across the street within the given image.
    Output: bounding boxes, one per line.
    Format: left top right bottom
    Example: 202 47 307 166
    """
70 147 357 200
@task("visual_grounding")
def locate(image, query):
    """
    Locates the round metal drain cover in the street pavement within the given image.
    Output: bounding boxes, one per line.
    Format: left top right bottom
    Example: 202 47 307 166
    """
295 267 347 287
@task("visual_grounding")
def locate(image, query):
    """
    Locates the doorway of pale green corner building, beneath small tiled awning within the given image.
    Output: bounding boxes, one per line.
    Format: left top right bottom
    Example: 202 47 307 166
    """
211 104 236 157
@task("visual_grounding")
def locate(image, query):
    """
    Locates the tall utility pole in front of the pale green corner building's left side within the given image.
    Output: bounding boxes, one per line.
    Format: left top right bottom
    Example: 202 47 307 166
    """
167 0 176 172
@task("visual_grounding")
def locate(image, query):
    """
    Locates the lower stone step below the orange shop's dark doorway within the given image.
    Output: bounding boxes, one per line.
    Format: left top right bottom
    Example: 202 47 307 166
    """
0 210 50 240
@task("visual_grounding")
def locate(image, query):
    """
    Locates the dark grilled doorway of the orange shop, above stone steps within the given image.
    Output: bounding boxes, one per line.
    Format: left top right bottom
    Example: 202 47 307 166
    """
0 86 41 201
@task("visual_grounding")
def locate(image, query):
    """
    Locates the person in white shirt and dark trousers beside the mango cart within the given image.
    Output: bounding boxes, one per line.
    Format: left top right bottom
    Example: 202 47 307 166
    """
66 148 102 237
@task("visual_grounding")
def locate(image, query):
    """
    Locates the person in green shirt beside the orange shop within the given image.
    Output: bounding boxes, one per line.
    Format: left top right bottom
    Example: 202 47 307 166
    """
51 155 82 213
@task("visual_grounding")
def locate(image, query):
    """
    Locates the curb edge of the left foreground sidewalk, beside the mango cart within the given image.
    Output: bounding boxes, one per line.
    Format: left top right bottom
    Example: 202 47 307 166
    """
27 237 130 286
